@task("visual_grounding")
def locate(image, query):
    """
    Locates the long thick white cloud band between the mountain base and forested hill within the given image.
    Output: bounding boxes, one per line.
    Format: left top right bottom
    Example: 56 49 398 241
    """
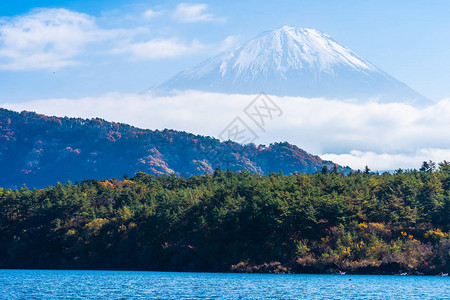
3 91 450 170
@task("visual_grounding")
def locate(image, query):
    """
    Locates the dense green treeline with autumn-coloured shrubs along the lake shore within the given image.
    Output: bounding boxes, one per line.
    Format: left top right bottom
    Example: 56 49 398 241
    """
0 162 450 274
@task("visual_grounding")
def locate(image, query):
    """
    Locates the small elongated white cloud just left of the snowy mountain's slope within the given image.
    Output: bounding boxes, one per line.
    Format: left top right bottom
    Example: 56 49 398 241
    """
112 39 205 60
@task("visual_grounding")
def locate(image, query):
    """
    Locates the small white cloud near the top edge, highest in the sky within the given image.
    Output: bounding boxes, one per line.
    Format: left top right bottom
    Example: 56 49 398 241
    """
172 3 225 23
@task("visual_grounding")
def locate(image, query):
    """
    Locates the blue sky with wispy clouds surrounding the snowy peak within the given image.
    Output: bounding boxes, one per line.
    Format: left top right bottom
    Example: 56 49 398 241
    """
0 0 450 104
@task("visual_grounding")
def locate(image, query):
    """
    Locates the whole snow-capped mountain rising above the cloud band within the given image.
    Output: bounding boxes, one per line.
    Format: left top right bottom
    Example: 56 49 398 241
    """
151 26 432 106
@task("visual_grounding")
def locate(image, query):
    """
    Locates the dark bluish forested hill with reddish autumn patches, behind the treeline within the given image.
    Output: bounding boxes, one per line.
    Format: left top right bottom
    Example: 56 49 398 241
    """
0 108 349 187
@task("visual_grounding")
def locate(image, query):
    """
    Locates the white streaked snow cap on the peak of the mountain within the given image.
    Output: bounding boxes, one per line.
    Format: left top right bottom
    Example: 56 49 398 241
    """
227 26 376 77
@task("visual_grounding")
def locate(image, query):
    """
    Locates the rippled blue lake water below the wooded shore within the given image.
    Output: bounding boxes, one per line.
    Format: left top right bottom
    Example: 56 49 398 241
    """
0 270 450 299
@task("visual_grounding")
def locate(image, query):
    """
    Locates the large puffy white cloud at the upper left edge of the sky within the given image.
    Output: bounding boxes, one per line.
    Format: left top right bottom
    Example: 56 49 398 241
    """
0 9 118 70
